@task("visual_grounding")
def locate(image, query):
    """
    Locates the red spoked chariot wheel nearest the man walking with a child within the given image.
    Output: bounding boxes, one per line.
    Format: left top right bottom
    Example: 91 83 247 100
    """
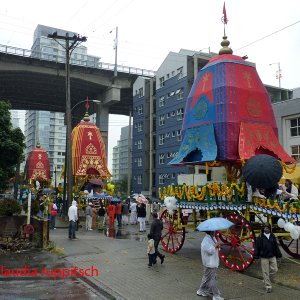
160 210 185 253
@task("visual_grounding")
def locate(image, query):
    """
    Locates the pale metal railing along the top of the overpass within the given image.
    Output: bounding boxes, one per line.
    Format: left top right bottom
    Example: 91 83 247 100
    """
0 44 156 77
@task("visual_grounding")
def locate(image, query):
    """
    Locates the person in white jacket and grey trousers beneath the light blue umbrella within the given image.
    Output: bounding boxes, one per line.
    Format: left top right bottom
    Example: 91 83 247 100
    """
197 231 224 300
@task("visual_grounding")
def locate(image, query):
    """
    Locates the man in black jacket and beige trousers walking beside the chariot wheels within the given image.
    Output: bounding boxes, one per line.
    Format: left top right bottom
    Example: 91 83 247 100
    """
254 223 282 293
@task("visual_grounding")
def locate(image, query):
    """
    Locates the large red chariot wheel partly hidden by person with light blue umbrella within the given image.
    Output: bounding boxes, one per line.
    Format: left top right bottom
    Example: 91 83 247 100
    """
216 214 255 271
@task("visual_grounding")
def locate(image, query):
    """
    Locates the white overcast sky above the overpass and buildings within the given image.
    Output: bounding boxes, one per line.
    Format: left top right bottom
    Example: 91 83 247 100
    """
0 0 300 167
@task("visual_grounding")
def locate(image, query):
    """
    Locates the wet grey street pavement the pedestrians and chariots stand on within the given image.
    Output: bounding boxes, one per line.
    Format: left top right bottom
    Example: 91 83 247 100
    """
50 218 300 300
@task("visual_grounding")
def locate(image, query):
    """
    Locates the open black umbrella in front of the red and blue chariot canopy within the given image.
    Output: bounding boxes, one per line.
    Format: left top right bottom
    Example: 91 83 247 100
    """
242 154 283 189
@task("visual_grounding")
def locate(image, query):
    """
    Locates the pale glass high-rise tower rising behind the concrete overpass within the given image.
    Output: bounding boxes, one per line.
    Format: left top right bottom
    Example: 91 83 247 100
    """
24 25 100 185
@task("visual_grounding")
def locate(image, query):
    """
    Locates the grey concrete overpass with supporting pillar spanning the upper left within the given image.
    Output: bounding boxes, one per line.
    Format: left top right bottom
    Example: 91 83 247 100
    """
0 45 155 144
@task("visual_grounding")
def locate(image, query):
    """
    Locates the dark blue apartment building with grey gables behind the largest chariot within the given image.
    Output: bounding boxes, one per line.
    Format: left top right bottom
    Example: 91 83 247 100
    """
132 49 215 197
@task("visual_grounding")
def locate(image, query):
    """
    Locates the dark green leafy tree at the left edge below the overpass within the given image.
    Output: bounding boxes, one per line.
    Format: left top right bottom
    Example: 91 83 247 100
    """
0 101 26 191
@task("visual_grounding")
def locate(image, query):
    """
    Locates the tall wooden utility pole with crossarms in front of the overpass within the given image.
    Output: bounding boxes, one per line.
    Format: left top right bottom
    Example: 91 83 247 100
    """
48 32 87 216
